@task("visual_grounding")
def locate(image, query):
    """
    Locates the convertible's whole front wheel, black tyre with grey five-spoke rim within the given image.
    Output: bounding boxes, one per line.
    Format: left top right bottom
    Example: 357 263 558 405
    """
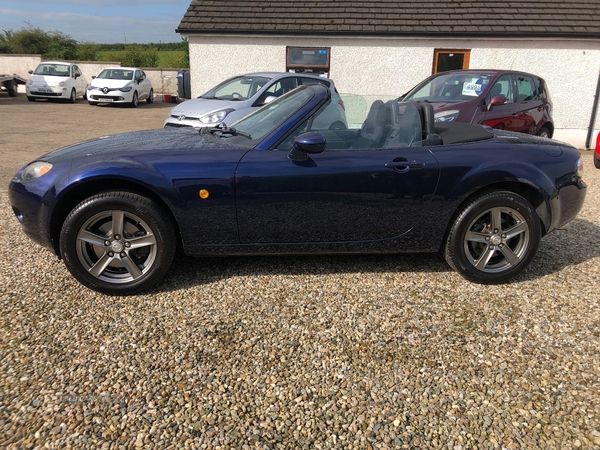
60 192 176 295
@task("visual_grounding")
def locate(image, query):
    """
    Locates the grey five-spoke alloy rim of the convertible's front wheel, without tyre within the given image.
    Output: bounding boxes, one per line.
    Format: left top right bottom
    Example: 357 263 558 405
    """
75 210 157 283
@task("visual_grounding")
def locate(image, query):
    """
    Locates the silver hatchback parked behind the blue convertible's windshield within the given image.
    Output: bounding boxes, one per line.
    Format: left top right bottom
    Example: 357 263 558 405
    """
164 72 348 129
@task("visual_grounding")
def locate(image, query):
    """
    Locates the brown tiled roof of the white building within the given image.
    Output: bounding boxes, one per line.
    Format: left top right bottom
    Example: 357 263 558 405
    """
176 0 600 39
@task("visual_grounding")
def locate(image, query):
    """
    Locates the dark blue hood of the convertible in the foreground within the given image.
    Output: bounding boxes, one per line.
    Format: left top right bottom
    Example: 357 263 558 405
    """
39 128 248 166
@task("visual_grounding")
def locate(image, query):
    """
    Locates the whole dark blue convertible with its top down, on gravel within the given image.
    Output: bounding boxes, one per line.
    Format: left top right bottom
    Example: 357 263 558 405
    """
9 85 586 295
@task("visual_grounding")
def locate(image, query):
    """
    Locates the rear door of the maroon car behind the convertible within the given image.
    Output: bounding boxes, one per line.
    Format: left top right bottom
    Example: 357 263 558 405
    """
514 74 544 134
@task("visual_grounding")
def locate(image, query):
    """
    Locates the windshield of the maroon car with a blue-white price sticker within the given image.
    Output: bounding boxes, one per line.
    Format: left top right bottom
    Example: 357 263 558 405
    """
402 73 492 103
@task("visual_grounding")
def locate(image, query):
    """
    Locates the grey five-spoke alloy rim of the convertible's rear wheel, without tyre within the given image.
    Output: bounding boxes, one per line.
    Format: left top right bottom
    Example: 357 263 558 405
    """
463 207 530 273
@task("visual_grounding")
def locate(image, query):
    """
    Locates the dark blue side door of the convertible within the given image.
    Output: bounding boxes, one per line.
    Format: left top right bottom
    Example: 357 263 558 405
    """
236 137 439 244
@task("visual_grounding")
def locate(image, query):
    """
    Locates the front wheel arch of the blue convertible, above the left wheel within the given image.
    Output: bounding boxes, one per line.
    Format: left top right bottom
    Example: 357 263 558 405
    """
50 179 181 255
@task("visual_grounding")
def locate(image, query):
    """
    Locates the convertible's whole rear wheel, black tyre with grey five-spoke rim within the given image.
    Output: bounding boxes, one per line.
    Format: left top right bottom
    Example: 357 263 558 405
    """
444 191 542 284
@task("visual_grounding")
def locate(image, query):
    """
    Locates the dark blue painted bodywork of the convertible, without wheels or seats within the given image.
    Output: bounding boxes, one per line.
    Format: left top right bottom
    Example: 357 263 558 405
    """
9 86 585 293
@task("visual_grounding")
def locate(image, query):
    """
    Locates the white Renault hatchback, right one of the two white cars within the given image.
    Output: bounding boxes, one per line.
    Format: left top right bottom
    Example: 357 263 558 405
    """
87 67 154 108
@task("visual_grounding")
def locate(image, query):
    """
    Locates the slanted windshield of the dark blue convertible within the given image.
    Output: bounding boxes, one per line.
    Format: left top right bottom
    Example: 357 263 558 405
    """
218 87 314 146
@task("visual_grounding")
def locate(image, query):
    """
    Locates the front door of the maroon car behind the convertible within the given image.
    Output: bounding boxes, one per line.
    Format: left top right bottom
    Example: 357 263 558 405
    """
473 74 519 130
